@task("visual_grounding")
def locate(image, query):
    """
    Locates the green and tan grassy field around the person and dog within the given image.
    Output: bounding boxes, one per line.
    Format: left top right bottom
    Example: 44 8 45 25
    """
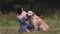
0 13 60 34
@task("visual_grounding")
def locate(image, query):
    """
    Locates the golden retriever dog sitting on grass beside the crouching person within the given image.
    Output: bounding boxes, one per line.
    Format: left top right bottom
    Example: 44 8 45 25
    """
28 11 49 31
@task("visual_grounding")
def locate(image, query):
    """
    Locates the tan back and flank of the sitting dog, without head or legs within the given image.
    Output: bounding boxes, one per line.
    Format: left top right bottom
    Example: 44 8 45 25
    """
33 15 49 31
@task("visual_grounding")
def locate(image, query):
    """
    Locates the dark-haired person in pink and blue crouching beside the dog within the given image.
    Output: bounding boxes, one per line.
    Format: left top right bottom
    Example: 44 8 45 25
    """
16 8 30 32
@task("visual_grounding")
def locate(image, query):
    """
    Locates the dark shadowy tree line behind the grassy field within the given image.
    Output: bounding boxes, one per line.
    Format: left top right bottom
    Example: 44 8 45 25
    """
0 0 60 13
